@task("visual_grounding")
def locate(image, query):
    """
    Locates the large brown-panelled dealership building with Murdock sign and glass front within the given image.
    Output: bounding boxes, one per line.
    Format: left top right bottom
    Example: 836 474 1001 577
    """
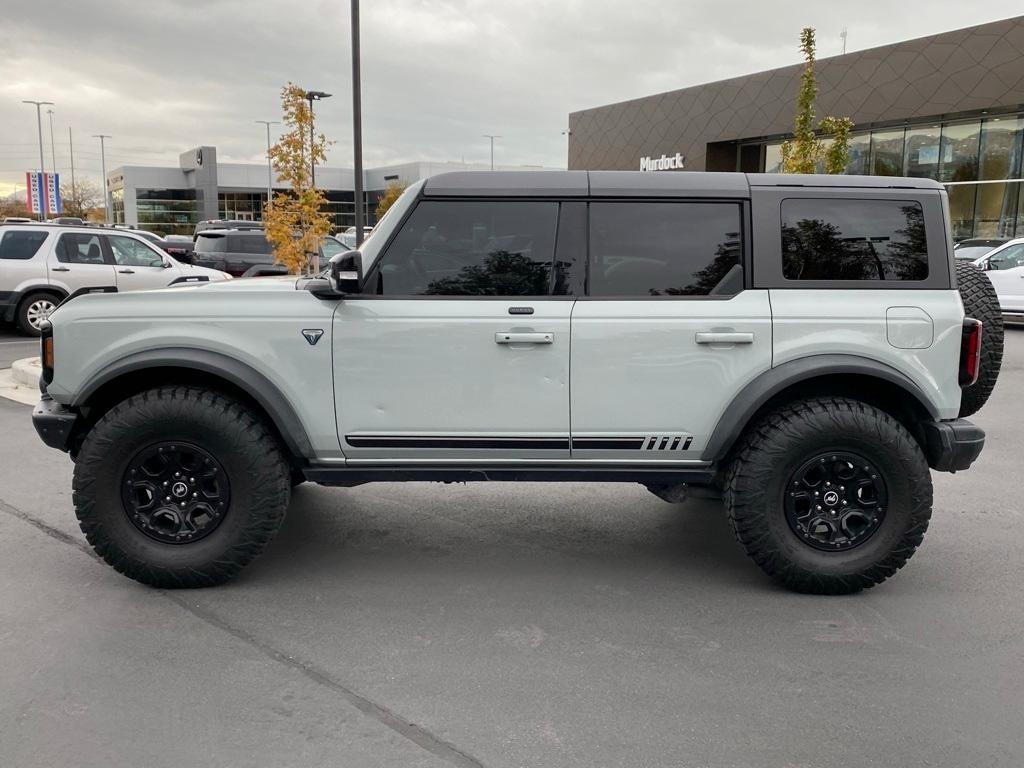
568 16 1024 239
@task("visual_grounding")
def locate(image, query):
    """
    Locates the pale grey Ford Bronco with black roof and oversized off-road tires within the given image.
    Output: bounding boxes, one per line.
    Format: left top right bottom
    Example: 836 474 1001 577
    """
33 171 1001 593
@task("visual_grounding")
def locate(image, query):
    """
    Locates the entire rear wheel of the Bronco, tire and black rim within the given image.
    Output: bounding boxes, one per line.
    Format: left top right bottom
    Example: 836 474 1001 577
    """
725 397 932 594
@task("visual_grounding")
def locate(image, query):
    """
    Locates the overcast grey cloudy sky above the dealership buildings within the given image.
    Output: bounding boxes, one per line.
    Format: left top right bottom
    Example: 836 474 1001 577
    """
0 0 1022 195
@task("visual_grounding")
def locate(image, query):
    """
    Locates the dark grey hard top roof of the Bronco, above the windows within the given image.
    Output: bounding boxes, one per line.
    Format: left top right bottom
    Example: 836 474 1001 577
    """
423 171 942 198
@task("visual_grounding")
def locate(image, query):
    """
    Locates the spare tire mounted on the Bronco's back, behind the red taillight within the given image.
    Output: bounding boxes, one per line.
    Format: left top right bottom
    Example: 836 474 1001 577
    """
956 261 1002 417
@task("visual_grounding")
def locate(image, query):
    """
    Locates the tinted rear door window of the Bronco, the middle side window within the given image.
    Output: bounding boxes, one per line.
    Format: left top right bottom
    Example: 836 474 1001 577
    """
590 203 743 296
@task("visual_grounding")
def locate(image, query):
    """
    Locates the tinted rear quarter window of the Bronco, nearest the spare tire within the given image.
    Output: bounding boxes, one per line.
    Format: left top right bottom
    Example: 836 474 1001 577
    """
782 199 928 281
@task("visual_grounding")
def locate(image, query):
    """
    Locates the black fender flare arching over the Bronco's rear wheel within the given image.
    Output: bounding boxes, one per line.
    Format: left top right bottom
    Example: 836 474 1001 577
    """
700 354 939 462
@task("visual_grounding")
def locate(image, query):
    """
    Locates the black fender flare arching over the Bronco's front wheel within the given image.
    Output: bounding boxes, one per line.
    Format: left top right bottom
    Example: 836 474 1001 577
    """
68 347 314 459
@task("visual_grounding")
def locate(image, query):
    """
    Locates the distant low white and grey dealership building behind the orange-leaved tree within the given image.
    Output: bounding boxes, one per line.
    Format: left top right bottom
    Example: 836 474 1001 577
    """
106 146 551 234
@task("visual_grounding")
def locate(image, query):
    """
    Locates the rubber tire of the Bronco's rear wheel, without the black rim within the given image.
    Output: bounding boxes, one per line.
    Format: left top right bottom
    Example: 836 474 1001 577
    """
724 397 932 595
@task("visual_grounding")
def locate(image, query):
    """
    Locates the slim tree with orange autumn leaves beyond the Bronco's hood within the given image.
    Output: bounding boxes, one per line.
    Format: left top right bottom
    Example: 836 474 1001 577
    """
263 83 331 274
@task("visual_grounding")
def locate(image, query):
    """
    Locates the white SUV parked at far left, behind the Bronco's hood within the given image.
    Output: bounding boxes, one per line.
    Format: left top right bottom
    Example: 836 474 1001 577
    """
0 224 228 336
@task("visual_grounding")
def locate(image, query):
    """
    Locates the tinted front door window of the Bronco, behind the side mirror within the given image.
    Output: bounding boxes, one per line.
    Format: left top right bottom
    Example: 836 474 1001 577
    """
371 201 558 296
